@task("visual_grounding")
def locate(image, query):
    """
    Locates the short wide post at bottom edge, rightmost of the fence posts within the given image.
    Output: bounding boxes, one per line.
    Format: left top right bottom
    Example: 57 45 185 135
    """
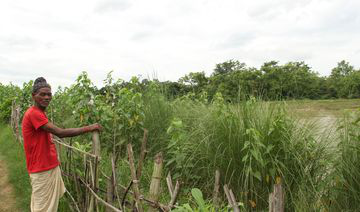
269 182 285 212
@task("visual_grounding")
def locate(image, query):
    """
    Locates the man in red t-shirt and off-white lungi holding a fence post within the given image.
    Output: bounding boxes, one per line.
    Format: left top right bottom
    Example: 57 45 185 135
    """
22 77 101 212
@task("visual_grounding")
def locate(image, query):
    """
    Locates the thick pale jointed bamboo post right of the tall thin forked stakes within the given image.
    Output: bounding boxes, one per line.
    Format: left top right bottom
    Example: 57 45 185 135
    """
149 152 163 211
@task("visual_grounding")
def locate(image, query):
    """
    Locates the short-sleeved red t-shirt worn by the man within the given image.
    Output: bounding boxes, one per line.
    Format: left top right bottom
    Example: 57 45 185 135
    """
22 106 59 173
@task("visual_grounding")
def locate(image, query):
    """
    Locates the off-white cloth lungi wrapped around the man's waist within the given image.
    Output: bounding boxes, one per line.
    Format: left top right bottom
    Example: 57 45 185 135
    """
30 166 65 212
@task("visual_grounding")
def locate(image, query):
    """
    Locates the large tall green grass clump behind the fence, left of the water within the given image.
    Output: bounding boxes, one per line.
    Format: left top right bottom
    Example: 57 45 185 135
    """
162 98 330 210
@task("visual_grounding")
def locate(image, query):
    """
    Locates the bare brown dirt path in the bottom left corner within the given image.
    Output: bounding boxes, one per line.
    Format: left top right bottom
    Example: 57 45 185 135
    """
0 158 18 212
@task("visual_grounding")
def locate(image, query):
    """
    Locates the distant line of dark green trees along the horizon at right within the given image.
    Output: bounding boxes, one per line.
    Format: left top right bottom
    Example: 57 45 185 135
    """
159 60 360 102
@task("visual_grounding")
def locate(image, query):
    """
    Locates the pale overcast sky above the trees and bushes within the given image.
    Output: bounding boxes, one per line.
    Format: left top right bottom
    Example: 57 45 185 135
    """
0 0 360 87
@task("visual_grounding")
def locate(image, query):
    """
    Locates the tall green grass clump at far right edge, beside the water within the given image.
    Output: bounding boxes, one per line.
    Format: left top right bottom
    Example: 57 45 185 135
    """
328 112 360 211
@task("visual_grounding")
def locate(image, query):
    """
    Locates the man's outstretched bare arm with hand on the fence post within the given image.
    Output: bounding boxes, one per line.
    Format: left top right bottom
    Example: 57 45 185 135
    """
40 122 102 138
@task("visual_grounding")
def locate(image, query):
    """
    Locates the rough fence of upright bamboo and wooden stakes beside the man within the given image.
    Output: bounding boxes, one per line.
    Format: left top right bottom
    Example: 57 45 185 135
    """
10 101 285 212
